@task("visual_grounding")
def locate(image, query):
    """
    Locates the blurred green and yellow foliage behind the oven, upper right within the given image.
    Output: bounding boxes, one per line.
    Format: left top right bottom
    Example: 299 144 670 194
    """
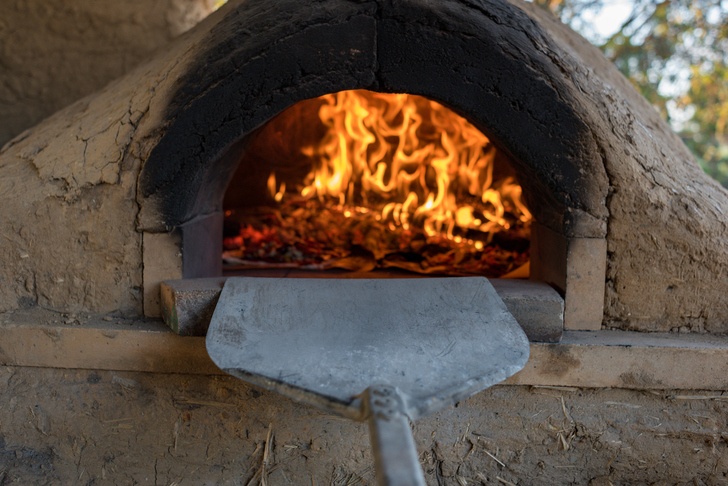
535 0 728 187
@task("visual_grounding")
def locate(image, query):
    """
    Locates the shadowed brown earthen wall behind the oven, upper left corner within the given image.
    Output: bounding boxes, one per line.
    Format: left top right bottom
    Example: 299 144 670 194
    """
0 0 214 146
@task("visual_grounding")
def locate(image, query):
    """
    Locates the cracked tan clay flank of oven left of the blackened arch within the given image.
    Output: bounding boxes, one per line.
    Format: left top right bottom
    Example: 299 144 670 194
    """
0 2 220 315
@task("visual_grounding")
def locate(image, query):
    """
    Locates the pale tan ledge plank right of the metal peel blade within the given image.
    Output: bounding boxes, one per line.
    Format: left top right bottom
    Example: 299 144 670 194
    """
508 331 728 390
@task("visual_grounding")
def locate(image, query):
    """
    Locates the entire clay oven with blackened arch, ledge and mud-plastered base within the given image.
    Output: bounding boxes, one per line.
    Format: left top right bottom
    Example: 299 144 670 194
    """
0 0 728 484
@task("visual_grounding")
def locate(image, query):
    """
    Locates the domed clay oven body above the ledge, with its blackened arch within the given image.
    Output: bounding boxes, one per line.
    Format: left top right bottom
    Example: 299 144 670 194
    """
0 0 728 338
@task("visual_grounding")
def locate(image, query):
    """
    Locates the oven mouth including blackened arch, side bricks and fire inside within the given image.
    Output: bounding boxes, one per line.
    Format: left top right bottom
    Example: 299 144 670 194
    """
137 2 608 340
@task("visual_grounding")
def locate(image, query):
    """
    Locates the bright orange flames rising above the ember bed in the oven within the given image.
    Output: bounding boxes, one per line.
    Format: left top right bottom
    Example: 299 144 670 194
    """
268 90 531 243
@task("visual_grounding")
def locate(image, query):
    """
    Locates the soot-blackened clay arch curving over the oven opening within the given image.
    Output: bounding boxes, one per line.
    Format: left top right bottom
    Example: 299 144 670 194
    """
140 0 608 237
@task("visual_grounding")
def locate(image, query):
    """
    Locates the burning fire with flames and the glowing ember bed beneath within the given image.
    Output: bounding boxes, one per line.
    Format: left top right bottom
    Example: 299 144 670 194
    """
226 90 531 274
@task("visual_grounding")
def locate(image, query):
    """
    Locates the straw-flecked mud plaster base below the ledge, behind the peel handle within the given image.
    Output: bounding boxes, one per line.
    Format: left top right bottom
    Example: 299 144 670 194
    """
0 367 728 486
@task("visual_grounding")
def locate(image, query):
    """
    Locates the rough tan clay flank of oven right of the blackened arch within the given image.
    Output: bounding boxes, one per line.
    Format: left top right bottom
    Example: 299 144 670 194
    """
516 3 728 333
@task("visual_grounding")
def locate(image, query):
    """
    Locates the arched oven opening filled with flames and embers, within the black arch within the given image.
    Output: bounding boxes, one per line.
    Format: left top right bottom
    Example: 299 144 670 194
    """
223 90 532 278
